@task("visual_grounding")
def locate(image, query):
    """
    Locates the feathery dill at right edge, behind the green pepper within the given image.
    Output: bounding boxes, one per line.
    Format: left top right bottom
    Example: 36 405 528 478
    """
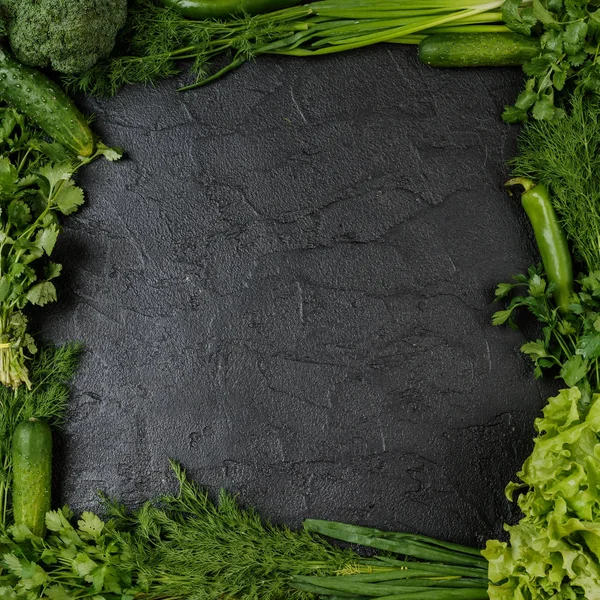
510 94 600 273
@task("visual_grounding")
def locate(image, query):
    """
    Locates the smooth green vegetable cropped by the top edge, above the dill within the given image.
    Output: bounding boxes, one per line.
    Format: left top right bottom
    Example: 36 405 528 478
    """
161 0 303 20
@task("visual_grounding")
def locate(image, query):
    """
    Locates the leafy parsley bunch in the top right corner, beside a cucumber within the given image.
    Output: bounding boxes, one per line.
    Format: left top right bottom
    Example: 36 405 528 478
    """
502 0 600 123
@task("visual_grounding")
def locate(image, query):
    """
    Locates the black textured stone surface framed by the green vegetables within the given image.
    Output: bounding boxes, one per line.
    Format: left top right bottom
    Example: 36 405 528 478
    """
37 45 548 544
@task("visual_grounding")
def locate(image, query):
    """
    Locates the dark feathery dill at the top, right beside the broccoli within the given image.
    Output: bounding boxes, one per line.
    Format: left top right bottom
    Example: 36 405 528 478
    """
63 0 311 96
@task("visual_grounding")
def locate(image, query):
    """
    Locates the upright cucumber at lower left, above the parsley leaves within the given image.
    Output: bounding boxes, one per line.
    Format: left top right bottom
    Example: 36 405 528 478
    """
12 419 52 537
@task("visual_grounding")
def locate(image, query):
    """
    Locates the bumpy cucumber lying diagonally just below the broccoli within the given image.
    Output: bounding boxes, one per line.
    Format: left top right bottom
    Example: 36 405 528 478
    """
0 49 94 156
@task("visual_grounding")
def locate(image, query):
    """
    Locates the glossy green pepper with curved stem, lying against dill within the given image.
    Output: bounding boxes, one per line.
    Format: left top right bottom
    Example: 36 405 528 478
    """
506 177 573 313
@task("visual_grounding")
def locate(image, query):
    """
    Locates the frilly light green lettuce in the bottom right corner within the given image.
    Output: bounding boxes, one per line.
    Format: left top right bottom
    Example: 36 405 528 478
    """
483 387 600 600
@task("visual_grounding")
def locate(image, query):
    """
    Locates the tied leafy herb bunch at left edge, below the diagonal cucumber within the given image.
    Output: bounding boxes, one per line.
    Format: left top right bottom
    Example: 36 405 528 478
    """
0 107 120 389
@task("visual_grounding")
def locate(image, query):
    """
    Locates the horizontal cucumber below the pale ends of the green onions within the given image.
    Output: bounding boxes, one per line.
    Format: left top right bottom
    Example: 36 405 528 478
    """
419 33 540 67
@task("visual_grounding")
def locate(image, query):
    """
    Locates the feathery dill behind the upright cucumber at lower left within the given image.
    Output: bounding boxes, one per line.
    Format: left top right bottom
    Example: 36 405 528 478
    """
0 343 82 528
